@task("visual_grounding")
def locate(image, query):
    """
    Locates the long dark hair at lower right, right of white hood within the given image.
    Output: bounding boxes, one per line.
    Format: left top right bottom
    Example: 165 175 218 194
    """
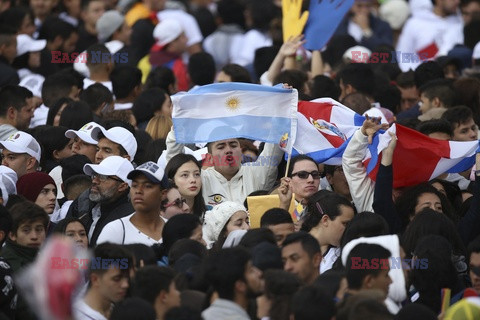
410 235 458 313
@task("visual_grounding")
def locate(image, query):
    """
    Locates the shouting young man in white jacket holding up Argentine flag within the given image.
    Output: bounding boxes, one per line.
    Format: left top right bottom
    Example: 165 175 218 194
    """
166 127 283 206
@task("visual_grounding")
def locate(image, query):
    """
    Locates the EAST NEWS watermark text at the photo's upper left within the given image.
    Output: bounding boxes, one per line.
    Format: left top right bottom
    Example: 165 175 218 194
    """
51 51 128 64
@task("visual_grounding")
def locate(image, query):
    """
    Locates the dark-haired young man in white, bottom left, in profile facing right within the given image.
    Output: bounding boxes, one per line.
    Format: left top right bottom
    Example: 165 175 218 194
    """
73 243 134 320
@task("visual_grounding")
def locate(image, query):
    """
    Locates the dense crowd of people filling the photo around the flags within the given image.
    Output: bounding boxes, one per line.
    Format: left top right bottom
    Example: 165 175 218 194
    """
0 0 480 320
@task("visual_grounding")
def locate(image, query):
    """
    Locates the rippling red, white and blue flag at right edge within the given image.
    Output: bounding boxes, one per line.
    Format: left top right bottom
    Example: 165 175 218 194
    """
364 124 479 188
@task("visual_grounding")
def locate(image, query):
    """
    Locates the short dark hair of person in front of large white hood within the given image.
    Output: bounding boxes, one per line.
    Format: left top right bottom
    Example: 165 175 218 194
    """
345 243 392 290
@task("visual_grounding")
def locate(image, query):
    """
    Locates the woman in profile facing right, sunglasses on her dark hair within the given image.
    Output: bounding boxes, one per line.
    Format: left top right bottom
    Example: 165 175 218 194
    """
301 190 355 273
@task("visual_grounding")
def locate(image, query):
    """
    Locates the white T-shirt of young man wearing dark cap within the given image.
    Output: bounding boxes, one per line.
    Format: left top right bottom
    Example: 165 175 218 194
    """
97 212 163 247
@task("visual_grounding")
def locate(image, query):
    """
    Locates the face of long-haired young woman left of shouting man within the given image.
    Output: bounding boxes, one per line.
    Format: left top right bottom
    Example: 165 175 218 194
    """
173 161 202 198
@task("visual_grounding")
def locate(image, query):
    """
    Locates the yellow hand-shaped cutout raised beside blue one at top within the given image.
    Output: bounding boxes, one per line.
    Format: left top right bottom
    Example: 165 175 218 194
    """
282 0 308 42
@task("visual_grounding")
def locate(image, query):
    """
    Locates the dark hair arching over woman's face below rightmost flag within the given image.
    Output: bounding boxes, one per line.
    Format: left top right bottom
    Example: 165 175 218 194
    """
395 183 453 227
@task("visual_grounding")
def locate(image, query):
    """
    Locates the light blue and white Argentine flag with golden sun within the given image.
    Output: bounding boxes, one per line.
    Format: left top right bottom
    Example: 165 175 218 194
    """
172 82 298 145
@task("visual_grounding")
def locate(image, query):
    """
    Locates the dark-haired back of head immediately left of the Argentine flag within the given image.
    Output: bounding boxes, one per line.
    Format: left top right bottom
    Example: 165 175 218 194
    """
132 88 167 123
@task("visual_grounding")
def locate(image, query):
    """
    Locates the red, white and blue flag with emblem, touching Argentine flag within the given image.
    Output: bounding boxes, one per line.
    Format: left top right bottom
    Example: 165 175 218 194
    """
292 98 365 165
